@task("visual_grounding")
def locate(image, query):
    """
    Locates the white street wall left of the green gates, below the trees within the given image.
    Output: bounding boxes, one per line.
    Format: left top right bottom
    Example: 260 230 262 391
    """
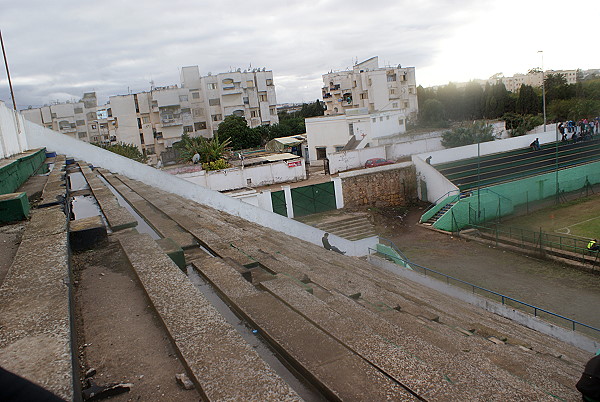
172 158 306 191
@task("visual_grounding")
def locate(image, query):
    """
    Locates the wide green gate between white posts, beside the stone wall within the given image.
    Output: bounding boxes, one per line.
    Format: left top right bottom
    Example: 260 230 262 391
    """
292 181 337 218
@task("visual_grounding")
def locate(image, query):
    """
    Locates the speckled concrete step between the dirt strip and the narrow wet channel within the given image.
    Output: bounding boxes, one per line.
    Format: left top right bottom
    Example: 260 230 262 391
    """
119 234 300 401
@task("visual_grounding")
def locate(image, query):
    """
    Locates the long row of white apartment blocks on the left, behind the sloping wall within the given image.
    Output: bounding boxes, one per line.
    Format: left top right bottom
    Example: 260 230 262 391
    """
22 66 279 163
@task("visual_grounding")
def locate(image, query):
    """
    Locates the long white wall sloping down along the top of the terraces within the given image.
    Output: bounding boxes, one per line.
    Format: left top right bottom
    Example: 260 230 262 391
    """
25 122 378 256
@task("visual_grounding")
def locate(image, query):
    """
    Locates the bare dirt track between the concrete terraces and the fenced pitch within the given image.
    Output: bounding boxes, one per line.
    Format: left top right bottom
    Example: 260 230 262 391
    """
369 206 600 328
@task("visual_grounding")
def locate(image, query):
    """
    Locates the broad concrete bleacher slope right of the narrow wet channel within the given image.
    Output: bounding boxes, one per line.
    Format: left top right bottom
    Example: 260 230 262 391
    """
99 171 586 400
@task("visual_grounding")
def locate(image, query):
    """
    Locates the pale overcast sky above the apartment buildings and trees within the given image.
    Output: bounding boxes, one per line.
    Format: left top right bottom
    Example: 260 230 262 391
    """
0 0 600 108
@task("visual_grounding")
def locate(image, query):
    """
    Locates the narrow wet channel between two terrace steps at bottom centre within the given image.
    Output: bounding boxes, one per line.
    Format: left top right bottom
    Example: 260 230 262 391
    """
187 264 327 401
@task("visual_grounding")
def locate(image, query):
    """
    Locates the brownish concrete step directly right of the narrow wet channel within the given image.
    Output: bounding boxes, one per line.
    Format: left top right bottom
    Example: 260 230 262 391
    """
197 259 416 400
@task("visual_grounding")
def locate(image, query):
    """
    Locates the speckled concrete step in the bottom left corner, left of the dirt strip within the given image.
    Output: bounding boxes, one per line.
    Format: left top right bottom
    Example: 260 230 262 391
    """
0 206 73 400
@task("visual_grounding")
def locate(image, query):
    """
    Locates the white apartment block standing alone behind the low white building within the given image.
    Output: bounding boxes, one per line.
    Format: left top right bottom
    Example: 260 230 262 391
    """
323 57 418 118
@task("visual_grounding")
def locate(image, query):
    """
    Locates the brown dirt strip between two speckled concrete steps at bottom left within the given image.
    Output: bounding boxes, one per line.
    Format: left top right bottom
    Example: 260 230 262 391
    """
72 240 200 401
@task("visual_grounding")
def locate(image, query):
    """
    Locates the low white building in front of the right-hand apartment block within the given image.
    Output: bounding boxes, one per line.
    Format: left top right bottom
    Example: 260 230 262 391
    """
305 108 406 163
